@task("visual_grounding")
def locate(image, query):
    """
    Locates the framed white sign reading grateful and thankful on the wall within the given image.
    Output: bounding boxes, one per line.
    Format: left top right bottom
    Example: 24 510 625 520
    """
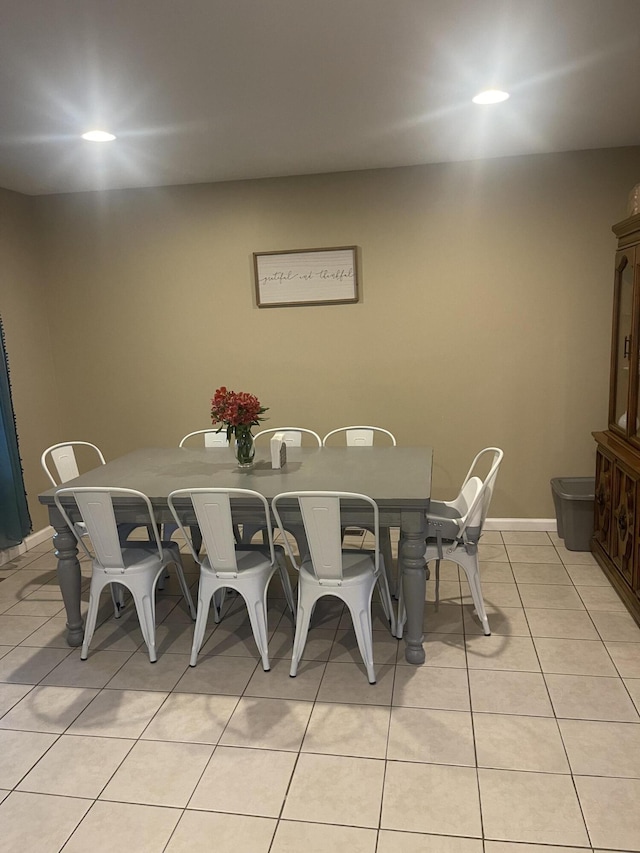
253 246 358 308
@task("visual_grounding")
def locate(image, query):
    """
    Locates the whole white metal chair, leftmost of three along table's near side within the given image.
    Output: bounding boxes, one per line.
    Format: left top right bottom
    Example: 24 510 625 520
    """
54 486 196 663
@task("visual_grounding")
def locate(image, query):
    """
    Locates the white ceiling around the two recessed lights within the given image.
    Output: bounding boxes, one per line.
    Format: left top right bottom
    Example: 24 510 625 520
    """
0 0 640 194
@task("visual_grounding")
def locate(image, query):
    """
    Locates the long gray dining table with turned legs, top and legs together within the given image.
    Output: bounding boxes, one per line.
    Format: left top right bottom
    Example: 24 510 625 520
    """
39 444 433 664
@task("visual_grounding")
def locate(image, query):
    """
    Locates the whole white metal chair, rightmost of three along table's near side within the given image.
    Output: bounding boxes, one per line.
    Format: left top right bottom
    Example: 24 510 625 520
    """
271 492 395 684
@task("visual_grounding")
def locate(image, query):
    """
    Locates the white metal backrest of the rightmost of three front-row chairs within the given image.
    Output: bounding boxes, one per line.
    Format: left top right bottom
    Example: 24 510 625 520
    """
271 492 380 586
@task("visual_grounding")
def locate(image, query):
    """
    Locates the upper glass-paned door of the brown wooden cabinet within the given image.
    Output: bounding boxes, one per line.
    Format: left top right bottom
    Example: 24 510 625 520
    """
609 248 638 437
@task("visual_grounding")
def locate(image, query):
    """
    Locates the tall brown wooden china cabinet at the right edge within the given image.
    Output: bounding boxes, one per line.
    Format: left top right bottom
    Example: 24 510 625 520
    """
592 215 640 624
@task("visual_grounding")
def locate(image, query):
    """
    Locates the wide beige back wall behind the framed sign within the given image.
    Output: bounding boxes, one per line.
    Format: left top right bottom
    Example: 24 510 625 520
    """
5 148 640 532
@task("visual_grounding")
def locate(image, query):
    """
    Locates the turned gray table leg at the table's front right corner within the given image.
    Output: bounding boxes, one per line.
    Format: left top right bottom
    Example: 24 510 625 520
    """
398 513 427 664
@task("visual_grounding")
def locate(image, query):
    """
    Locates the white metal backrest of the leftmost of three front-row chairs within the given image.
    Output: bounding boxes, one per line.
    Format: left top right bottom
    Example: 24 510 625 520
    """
54 486 162 569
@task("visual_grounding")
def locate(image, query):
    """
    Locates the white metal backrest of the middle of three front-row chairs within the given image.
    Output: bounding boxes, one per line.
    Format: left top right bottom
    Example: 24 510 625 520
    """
167 488 275 577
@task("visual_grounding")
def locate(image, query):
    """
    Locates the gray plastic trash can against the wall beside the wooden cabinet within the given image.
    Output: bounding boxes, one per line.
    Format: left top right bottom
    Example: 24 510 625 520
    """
551 477 596 551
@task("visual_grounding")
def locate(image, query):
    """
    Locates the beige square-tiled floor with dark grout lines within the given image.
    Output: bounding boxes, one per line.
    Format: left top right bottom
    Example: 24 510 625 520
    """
0 532 640 853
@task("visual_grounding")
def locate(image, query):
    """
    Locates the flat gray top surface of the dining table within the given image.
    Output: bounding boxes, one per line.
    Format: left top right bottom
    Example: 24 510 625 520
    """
39 444 432 512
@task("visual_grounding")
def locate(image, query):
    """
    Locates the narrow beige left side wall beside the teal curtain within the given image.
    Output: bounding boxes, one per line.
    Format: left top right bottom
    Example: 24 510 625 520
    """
0 189 60 530
